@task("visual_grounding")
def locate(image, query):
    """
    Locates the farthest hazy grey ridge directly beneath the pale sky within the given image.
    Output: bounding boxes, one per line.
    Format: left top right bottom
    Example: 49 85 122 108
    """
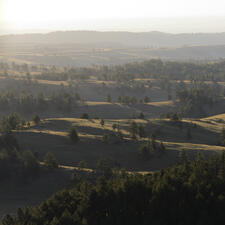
0 31 225 47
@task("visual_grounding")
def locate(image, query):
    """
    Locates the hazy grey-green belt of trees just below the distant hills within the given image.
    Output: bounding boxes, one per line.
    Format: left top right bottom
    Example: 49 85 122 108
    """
0 59 225 82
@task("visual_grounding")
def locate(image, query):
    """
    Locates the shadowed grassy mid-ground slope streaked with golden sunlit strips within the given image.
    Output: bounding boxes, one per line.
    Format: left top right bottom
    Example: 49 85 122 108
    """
16 115 225 170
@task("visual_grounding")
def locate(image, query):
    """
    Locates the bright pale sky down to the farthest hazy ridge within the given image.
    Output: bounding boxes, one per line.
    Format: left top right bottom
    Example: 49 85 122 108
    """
0 0 225 33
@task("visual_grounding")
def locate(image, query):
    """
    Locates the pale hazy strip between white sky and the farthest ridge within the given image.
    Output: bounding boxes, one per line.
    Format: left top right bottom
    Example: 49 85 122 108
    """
0 16 225 35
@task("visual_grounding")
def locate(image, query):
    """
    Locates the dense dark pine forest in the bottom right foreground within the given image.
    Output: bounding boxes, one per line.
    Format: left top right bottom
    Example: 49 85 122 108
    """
2 152 225 225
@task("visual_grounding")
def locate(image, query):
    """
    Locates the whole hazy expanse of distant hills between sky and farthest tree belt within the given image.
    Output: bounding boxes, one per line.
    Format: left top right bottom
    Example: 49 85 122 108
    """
0 31 225 66
